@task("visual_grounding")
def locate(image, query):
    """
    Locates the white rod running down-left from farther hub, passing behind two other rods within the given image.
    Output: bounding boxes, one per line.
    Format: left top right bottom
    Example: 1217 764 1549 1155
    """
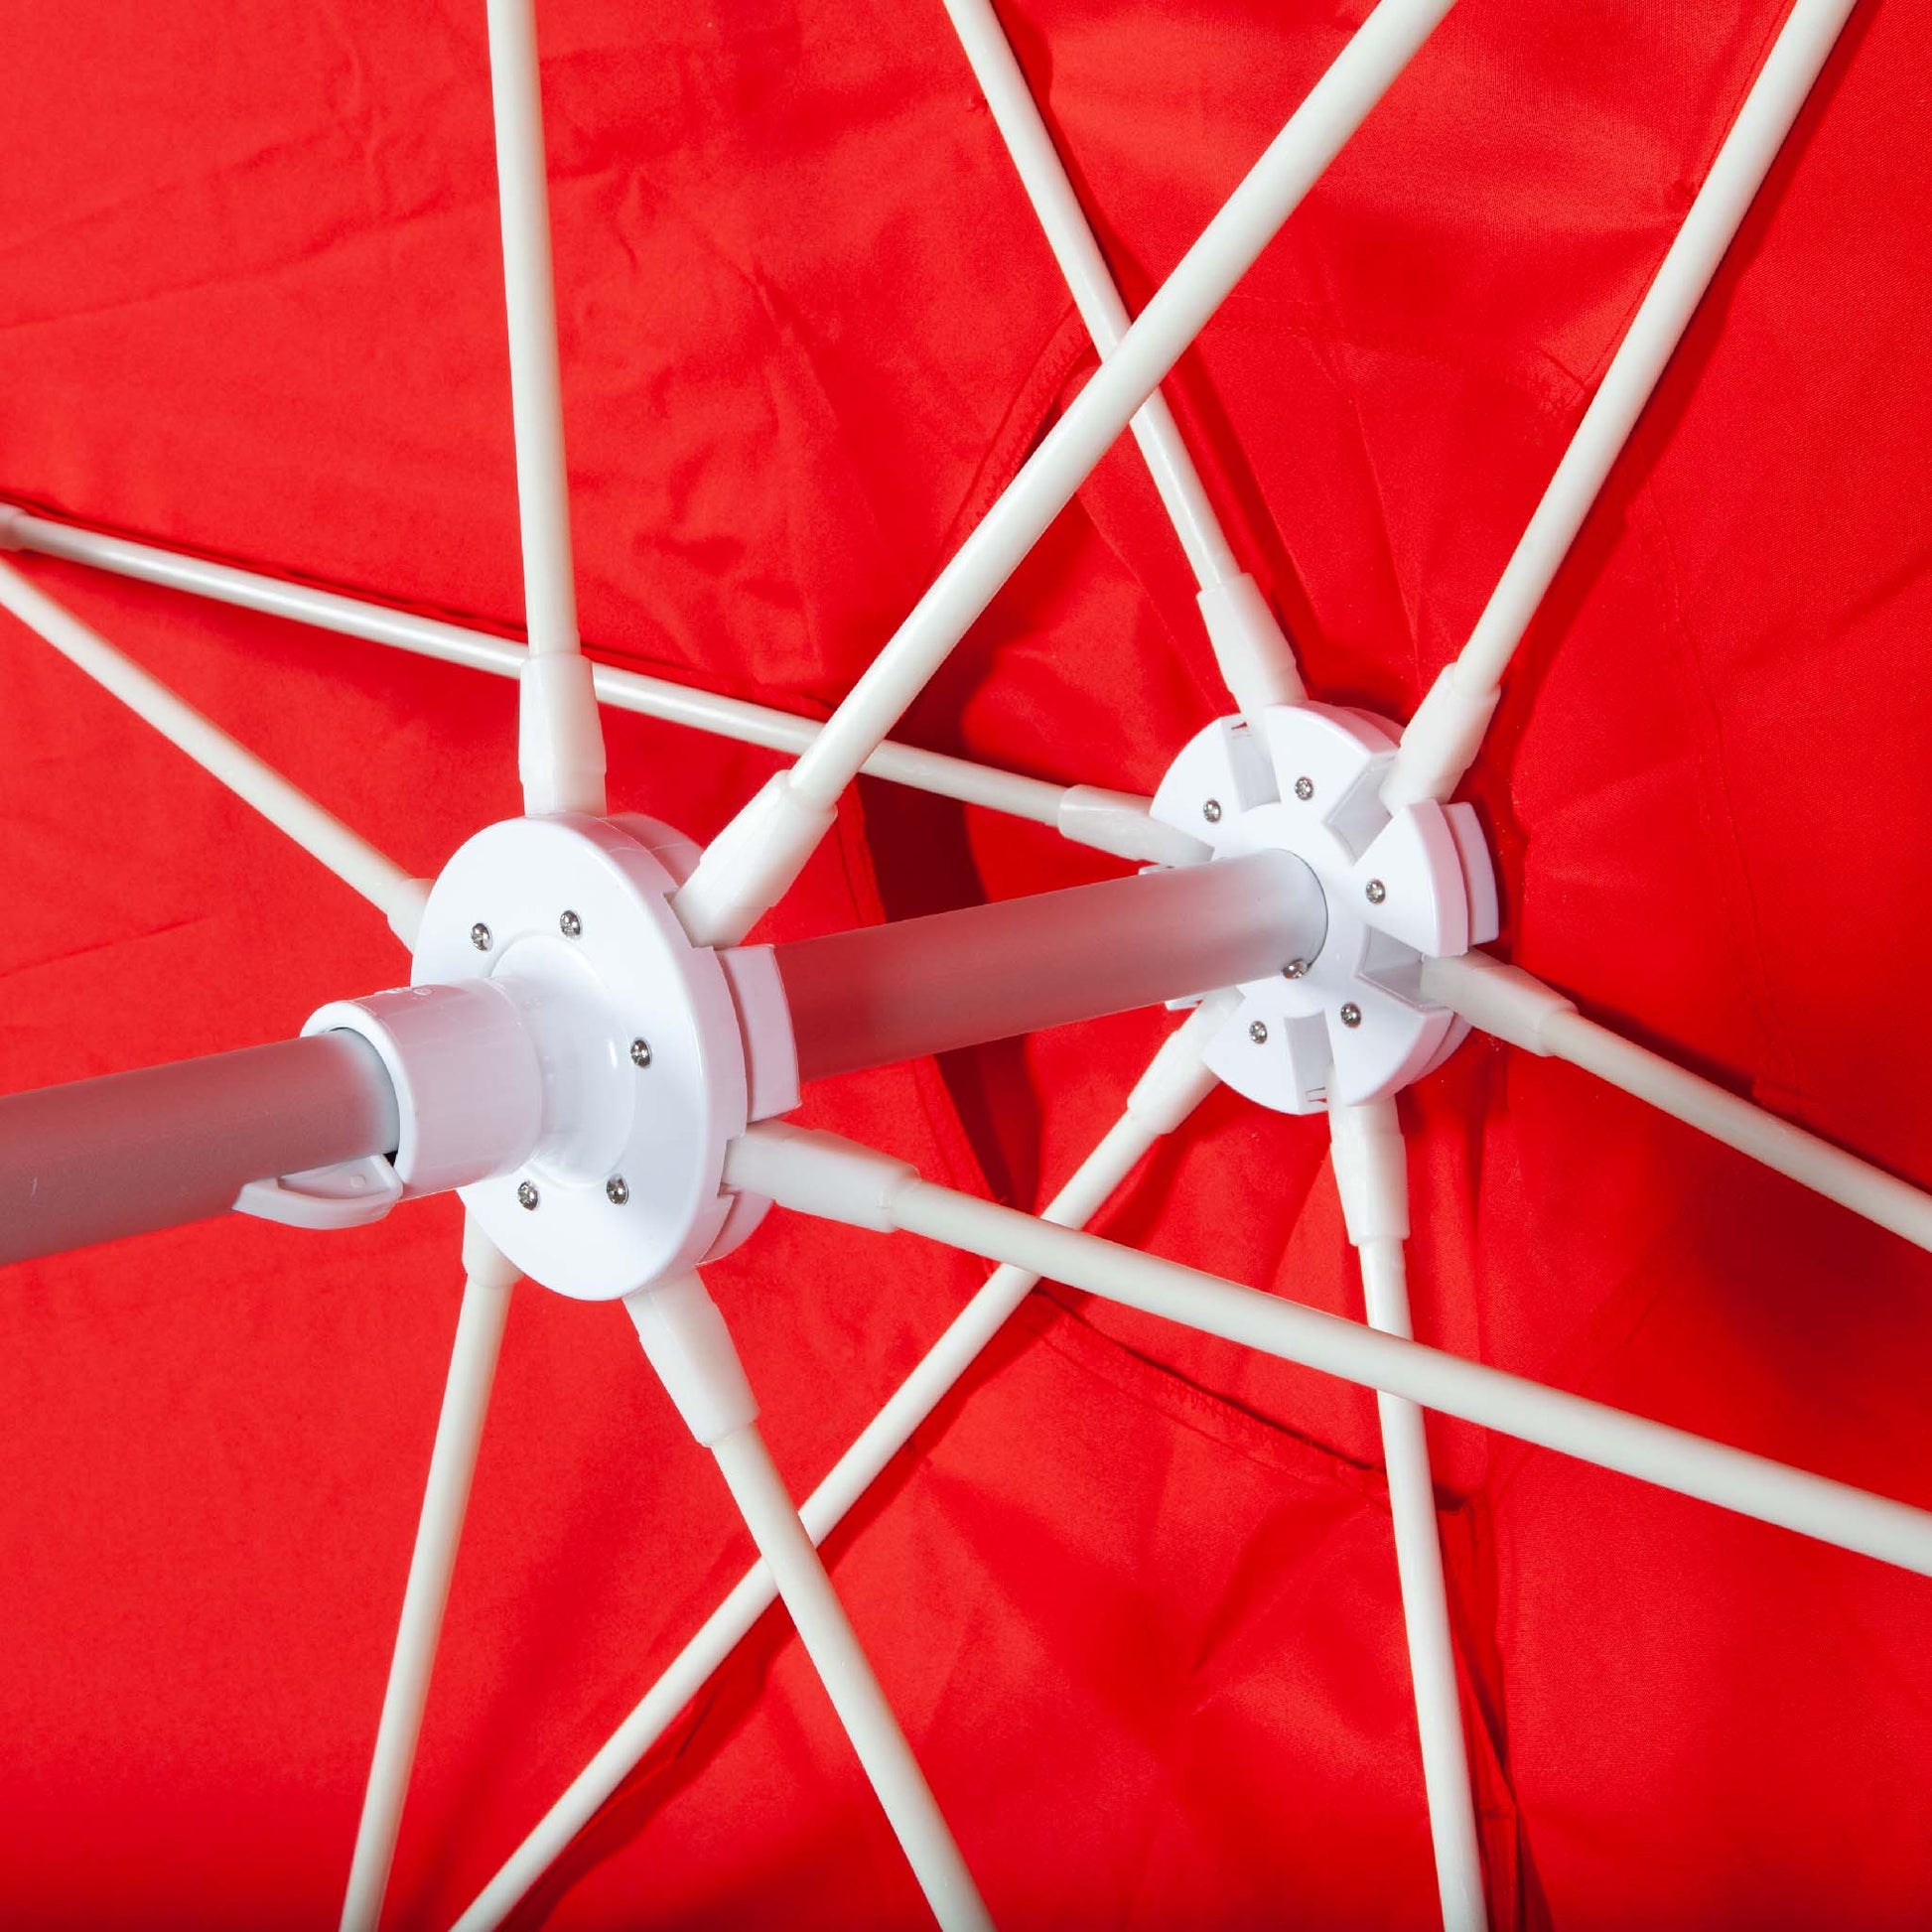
456 999 1231 1932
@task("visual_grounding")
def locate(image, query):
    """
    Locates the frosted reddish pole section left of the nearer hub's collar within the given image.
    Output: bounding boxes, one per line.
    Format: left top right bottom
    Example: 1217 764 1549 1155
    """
0 1034 396 1264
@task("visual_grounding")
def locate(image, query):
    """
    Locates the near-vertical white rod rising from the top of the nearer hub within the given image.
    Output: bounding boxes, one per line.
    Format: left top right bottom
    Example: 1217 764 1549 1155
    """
488 0 605 813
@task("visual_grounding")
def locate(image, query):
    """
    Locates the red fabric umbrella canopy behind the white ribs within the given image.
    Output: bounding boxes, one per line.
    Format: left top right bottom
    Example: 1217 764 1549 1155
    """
0 0 1932 1928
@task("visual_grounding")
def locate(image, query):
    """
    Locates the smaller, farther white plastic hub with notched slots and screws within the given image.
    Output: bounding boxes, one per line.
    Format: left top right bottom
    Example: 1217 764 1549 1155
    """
1154 705 1497 1113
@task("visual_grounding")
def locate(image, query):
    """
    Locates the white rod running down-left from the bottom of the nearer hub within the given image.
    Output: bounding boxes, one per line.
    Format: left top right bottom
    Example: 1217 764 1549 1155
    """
342 1225 516 1932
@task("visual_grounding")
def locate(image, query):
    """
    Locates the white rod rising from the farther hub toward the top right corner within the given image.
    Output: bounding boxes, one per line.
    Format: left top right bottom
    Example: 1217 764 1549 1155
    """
1383 0 1855 804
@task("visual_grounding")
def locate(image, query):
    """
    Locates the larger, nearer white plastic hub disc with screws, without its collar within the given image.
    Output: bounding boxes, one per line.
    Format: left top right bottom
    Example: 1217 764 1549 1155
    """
411 815 796 1301
